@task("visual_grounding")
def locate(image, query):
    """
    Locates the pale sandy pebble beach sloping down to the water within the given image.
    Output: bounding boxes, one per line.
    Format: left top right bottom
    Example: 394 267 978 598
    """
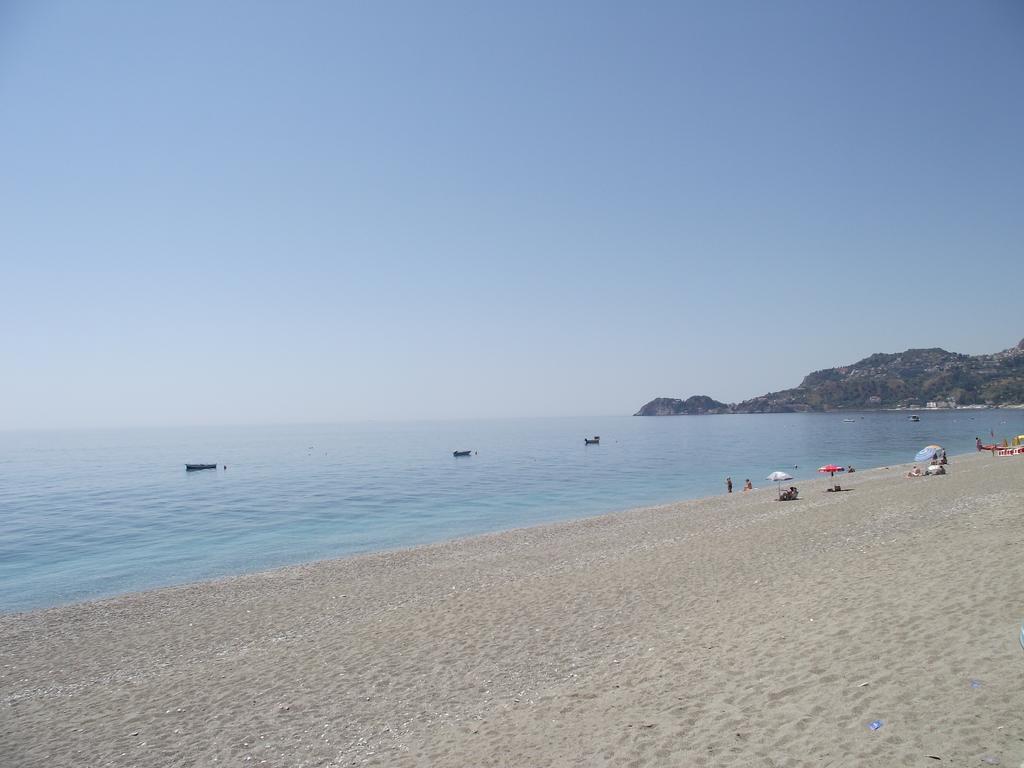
0 454 1024 768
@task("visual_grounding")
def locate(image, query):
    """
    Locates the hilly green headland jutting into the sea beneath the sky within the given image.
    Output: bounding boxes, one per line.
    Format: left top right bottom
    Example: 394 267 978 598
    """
634 339 1024 416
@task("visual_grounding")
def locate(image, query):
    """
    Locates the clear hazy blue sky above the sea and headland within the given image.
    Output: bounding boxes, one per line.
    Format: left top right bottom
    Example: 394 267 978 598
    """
0 0 1024 428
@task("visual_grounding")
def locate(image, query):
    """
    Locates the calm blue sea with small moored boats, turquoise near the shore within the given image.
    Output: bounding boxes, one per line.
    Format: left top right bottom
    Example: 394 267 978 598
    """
0 411 1024 612
